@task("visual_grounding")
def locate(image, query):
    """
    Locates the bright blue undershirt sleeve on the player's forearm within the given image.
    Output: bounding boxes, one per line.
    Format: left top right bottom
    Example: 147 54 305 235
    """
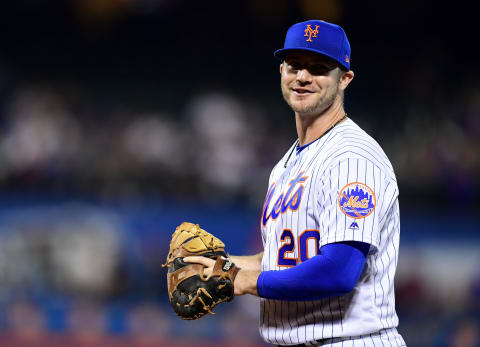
257 241 370 301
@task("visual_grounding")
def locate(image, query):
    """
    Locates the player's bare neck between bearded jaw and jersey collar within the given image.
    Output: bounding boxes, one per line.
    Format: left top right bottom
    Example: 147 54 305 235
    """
295 104 345 146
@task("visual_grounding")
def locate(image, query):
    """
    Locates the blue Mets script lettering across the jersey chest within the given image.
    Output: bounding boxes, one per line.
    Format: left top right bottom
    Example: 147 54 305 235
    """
262 171 308 226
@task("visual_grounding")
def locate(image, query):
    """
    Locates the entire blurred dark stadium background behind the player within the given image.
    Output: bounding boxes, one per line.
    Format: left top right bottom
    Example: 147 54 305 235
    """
0 0 480 347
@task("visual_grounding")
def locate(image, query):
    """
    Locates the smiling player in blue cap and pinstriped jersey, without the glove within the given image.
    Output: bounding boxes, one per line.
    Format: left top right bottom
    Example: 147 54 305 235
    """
185 20 405 347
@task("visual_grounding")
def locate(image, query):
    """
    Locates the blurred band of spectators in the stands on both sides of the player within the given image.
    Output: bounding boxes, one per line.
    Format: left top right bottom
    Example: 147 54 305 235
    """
0 81 480 207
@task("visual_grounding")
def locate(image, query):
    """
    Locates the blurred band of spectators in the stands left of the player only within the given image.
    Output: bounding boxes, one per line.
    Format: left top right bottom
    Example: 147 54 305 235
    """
0 86 284 204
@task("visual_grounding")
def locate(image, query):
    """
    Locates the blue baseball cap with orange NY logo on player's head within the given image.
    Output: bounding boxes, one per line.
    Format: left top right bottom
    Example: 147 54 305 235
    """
273 20 350 70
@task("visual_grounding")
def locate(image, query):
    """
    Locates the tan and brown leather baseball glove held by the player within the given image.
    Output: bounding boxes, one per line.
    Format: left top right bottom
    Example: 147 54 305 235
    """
164 222 240 320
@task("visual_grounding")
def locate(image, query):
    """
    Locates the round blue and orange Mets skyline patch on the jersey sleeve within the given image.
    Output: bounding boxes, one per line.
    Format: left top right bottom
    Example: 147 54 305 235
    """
338 182 377 219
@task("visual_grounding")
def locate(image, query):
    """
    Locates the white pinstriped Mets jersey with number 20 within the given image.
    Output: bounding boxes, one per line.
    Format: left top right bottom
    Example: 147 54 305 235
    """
260 119 405 346
